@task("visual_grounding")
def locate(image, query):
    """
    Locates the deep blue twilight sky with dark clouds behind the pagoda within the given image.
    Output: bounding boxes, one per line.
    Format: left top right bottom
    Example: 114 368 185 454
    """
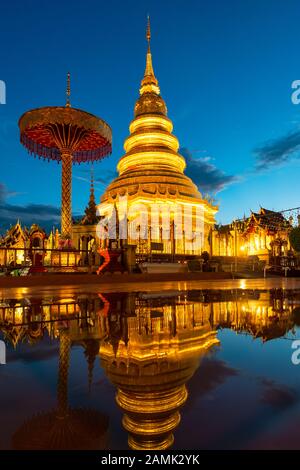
0 0 300 226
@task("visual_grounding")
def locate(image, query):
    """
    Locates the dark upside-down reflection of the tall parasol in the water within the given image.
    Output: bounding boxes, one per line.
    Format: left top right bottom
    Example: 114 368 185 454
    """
13 330 108 450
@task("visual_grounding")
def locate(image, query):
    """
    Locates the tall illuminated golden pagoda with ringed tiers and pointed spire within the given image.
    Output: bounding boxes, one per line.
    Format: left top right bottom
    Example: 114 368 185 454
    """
99 18 217 255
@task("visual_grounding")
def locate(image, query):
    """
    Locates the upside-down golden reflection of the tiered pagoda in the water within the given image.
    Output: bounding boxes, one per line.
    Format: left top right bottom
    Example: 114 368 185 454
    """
100 294 218 449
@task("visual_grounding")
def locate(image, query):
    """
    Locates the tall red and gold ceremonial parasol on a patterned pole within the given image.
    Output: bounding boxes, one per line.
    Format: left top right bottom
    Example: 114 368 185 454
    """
19 73 112 239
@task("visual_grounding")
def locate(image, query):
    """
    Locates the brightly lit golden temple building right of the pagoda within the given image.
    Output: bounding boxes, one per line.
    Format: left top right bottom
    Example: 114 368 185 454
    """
211 208 292 264
